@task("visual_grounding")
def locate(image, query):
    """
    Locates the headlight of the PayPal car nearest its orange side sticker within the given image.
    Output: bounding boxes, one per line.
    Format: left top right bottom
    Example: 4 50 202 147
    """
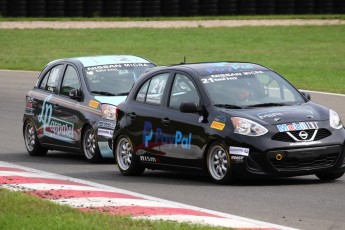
231 117 268 136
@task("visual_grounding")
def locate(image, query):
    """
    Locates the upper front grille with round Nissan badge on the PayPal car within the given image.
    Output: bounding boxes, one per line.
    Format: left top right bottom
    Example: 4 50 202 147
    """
272 129 332 142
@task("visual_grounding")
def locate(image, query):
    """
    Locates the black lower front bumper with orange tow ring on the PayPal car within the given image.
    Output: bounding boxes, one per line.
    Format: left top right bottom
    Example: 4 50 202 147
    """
232 145 345 177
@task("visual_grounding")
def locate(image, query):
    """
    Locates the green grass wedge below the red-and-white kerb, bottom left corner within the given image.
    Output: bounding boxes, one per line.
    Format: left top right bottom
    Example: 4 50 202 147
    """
0 189 223 230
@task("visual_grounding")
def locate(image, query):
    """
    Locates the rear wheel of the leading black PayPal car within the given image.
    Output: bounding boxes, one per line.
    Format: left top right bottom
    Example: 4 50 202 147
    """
115 135 145 176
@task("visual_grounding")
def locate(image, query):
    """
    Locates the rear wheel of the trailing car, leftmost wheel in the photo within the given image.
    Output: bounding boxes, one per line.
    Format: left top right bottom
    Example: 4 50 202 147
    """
23 121 48 156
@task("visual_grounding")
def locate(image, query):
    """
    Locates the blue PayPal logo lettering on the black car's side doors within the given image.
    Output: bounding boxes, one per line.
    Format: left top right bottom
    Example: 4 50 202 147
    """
143 121 192 149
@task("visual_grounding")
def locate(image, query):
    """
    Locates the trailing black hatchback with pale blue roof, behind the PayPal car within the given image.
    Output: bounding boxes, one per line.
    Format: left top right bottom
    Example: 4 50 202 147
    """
23 55 156 162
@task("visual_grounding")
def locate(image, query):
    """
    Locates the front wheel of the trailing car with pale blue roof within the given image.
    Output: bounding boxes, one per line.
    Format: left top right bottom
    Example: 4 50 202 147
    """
82 126 102 163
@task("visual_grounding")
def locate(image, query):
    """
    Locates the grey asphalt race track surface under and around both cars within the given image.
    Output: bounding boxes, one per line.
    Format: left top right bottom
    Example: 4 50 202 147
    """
0 71 345 229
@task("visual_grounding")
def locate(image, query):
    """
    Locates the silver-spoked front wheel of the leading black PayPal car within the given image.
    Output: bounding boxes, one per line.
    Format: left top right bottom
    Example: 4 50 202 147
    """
206 142 233 184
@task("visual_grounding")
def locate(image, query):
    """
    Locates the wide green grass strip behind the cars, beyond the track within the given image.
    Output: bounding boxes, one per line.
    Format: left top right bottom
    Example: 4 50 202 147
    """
0 25 345 94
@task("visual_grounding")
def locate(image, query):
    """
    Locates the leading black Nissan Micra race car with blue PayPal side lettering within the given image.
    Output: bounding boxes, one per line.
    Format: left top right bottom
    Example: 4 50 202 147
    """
113 62 345 183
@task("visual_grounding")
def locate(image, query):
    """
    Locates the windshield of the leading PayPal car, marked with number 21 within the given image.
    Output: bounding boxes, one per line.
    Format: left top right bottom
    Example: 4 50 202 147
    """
200 70 305 109
